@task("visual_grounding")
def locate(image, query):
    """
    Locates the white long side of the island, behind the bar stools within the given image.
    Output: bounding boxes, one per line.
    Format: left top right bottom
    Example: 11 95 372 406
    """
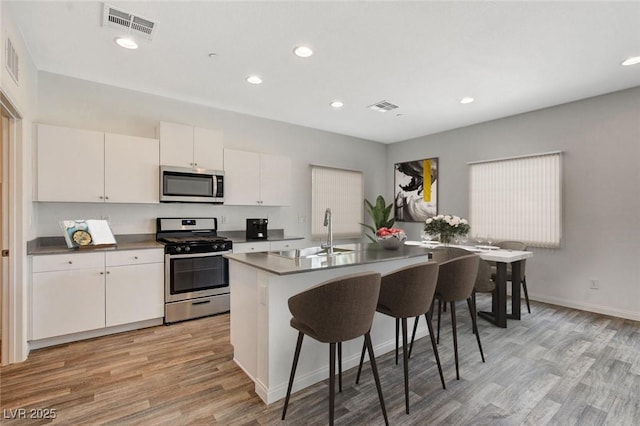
260 257 426 404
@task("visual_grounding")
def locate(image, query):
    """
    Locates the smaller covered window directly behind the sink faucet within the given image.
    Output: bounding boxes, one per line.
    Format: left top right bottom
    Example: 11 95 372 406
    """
311 166 364 238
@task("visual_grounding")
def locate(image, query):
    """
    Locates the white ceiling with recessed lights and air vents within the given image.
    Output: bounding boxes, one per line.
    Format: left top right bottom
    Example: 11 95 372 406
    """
3 0 640 143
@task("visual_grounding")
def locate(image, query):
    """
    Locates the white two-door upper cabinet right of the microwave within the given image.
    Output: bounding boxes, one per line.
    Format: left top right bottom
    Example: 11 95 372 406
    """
224 149 291 206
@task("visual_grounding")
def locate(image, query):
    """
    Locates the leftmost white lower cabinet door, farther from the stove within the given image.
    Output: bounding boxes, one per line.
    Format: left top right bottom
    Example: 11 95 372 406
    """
31 268 105 340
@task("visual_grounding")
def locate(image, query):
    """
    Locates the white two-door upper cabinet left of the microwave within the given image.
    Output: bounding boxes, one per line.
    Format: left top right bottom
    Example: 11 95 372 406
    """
36 124 160 203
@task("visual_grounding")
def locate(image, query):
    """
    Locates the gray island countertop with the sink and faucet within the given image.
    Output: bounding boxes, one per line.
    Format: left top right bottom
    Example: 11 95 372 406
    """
225 244 431 275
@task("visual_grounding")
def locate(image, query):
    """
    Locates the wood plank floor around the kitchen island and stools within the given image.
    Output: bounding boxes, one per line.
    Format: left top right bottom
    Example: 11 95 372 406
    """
0 297 640 426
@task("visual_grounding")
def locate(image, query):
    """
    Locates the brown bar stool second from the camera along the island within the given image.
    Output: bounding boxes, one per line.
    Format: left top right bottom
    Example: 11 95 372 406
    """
356 262 446 414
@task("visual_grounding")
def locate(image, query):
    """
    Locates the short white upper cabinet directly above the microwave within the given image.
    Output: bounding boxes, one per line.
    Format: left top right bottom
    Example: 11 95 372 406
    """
160 121 224 170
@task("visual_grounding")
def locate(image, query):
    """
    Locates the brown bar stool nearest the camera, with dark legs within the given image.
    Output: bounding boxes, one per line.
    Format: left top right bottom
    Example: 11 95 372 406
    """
282 272 389 425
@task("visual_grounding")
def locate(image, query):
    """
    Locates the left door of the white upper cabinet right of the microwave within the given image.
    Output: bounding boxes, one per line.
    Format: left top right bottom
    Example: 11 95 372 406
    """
224 149 260 206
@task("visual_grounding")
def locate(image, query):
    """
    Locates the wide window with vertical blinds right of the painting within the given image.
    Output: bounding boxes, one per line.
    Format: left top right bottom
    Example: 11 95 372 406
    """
469 152 562 247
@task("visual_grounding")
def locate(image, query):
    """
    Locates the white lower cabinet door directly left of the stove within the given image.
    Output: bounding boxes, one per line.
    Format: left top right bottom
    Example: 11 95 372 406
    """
106 263 164 327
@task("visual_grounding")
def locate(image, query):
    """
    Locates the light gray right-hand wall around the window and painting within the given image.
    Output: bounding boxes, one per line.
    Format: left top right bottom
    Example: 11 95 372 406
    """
386 88 640 320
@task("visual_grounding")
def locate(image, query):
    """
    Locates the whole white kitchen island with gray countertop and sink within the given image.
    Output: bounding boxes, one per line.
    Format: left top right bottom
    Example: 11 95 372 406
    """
226 244 428 404
